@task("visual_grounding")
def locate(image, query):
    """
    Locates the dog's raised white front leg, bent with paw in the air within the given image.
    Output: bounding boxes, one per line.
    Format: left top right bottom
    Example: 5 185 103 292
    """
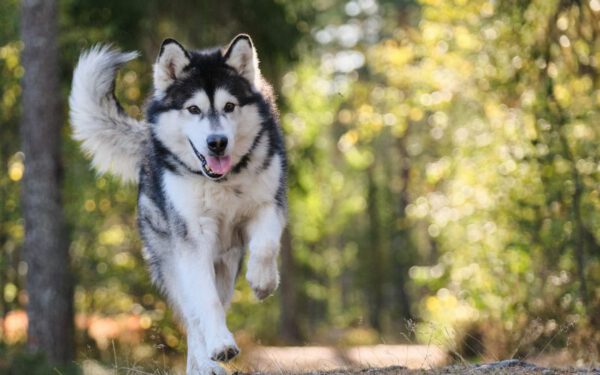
246 204 285 300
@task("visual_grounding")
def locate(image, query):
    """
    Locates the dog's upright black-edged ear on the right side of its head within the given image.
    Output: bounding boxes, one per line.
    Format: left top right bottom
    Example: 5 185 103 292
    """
223 34 260 84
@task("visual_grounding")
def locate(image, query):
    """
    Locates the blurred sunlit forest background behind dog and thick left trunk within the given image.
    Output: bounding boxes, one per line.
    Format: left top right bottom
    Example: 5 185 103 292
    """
0 0 600 374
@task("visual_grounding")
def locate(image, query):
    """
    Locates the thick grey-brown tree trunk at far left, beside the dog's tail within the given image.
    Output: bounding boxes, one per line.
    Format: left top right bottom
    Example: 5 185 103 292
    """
21 0 73 364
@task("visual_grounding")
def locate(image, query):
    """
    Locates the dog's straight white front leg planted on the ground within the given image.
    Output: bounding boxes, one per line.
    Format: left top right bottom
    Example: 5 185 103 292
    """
165 244 239 375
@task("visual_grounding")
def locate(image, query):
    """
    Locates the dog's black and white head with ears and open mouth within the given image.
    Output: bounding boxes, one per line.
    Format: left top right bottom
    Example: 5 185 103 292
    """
148 35 261 180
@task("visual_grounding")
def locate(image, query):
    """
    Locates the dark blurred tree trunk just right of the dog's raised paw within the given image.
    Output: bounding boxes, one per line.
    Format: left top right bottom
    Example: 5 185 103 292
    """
279 228 302 344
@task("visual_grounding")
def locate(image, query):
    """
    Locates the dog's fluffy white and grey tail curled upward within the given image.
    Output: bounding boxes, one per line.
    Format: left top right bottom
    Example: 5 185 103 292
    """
69 46 149 181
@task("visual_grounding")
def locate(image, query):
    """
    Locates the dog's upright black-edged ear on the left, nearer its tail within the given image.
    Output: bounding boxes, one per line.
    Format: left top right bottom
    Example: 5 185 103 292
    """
154 39 190 91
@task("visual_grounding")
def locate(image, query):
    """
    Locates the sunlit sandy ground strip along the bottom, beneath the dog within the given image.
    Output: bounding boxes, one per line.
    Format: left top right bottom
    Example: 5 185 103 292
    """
82 345 600 375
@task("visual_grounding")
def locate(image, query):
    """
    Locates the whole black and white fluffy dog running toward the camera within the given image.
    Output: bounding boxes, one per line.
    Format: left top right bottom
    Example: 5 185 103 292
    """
70 35 287 374
